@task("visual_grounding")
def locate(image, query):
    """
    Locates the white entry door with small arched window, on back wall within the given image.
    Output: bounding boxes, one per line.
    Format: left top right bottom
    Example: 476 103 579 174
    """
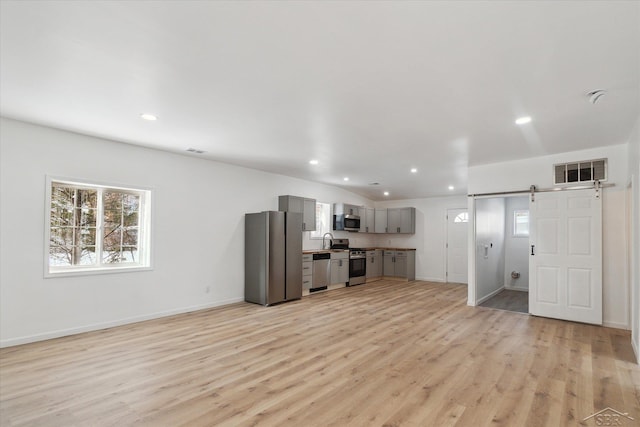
447 209 469 283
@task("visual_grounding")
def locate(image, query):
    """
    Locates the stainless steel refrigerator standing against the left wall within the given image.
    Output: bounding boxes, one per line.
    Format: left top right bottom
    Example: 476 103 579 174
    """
244 211 302 305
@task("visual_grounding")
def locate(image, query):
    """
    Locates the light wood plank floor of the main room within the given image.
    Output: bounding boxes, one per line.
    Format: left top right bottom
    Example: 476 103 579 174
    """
0 281 640 427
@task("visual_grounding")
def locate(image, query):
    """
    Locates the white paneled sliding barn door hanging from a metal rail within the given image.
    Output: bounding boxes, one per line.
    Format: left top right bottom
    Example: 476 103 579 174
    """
529 189 602 325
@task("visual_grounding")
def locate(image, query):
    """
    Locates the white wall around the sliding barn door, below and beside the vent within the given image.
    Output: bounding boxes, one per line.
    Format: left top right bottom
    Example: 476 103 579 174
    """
468 144 630 329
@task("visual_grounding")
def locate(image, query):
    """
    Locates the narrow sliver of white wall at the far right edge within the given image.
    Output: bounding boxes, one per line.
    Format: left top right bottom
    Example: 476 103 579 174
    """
627 117 640 363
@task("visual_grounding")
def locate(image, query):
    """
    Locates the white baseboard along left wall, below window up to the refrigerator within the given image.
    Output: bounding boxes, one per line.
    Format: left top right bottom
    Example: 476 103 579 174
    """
0 298 244 348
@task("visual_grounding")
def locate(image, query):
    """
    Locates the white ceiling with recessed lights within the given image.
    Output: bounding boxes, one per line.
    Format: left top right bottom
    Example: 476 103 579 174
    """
0 1 640 200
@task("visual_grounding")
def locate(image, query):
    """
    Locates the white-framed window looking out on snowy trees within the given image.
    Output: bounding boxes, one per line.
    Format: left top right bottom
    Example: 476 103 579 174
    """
45 178 151 276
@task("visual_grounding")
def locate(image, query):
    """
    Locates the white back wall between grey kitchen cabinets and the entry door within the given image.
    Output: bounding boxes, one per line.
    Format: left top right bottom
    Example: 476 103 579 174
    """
375 196 467 282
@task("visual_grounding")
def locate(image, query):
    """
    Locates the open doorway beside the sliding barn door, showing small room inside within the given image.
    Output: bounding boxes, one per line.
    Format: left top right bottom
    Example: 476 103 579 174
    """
475 196 529 313
